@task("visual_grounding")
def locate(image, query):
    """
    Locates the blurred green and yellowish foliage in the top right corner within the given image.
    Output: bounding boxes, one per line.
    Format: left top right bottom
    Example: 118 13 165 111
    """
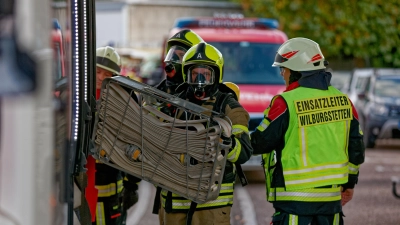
231 0 400 67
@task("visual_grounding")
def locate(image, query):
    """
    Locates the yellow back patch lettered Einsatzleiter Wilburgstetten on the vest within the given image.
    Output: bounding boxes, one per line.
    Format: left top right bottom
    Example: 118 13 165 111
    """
294 95 353 127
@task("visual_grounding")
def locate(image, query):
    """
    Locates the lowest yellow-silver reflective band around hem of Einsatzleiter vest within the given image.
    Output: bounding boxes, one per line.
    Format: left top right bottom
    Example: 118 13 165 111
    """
268 187 341 202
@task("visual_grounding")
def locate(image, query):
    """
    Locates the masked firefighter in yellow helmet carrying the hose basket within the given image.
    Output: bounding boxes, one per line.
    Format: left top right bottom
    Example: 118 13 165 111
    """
159 42 253 225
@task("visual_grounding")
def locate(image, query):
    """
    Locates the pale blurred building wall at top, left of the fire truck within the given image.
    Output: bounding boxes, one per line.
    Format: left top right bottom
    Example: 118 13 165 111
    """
96 0 242 48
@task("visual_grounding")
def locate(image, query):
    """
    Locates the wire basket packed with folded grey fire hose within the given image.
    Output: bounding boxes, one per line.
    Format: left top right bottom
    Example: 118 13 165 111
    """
92 77 231 203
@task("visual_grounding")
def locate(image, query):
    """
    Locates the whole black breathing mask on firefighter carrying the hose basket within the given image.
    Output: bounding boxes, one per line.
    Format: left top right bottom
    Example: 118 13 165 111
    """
187 65 215 99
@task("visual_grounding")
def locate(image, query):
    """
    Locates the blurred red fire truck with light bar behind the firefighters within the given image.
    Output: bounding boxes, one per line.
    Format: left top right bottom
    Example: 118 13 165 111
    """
170 15 287 130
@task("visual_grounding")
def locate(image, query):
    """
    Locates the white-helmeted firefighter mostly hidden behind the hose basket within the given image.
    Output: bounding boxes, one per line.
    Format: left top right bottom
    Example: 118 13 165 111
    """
88 46 140 225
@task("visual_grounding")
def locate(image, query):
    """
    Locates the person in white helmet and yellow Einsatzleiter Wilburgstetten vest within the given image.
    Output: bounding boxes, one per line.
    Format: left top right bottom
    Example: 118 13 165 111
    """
251 38 365 225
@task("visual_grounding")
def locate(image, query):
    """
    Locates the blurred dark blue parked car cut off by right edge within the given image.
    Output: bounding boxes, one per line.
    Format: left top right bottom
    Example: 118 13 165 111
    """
357 69 400 148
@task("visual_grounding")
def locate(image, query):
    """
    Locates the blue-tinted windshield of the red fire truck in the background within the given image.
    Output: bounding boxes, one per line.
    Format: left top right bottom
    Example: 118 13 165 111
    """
208 42 284 85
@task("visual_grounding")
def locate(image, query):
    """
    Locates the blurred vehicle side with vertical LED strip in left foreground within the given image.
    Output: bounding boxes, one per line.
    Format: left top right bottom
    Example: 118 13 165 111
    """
0 0 96 225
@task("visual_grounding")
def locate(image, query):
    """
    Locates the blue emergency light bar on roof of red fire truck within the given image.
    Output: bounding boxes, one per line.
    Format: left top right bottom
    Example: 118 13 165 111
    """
174 17 279 29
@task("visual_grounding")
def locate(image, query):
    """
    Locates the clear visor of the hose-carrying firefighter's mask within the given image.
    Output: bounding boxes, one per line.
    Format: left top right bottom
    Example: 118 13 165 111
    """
187 65 215 86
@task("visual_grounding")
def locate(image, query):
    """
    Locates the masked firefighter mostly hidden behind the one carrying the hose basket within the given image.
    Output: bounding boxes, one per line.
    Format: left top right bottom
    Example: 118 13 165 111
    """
157 29 203 95
